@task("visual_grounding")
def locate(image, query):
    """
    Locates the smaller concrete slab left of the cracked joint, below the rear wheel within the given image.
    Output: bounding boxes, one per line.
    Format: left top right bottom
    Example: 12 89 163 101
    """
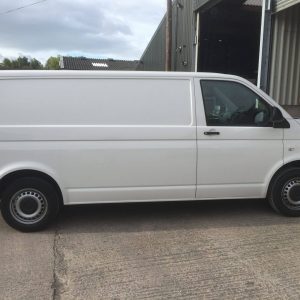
0 217 54 300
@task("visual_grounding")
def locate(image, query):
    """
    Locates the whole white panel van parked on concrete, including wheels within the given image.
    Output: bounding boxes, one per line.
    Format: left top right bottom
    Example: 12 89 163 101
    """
0 71 300 231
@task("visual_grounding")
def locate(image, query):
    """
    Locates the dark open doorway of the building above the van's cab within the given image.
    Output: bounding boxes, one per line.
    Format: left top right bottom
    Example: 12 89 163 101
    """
197 0 261 83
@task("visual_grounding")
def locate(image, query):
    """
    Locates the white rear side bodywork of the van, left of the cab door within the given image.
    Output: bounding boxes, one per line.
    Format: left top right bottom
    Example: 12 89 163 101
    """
0 78 196 204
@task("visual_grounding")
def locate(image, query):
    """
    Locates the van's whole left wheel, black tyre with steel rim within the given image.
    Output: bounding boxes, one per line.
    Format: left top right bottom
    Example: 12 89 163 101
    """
1 177 60 232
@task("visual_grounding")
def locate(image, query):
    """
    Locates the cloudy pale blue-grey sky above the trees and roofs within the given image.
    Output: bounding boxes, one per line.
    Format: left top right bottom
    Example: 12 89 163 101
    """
0 0 166 62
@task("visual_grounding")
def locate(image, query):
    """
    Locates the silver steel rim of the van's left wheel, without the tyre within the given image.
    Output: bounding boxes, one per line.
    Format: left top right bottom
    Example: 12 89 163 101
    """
10 189 48 224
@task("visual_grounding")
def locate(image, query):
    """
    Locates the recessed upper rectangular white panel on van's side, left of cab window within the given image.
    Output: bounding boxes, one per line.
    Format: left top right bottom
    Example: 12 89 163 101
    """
0 78 192 127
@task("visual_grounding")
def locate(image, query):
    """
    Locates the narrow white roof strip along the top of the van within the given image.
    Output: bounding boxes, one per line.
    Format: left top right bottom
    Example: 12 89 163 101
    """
0 70 240 79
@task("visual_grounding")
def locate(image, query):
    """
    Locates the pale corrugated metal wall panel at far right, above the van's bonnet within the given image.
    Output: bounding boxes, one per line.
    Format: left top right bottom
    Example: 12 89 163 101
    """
270 4 300 105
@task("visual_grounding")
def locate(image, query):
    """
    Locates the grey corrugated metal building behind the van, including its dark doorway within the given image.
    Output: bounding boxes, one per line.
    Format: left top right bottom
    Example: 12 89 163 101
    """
139 0 300 117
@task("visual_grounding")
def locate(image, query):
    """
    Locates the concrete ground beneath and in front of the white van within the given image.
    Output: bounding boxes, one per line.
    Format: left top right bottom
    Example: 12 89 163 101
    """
0 200 300 300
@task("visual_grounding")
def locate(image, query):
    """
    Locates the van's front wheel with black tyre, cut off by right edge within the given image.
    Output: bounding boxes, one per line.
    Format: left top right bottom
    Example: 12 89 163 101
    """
268 167 300 217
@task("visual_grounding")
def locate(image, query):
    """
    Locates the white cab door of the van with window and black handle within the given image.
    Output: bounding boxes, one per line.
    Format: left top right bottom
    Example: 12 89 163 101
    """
195 79 283 199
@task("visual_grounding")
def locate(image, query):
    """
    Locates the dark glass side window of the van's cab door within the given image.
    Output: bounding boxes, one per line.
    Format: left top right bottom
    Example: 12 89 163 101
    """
201 80 272 127
